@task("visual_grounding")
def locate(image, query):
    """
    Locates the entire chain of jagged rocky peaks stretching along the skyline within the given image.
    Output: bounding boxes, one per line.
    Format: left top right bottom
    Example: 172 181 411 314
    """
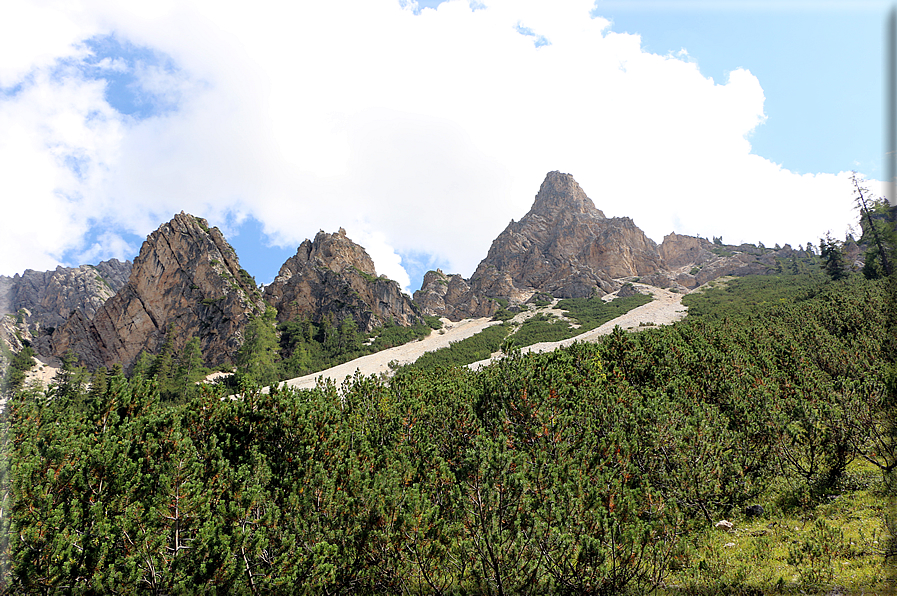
8 172 824 369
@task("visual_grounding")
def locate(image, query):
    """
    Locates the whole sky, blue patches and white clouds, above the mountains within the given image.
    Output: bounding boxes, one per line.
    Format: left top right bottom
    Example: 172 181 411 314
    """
0 0 892 292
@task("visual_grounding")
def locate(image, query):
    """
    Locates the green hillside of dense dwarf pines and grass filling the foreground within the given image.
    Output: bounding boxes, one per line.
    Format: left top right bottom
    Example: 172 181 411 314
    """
3 277 897 594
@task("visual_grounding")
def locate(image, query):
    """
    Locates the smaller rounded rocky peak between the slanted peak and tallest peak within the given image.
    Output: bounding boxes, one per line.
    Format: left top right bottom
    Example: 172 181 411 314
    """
265 228 422 332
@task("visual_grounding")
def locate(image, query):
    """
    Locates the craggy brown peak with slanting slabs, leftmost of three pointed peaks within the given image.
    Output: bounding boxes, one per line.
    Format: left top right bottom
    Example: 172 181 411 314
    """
50 212 265 369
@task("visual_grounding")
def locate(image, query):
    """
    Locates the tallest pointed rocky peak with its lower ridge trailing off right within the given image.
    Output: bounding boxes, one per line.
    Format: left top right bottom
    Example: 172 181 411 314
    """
414 172 809 320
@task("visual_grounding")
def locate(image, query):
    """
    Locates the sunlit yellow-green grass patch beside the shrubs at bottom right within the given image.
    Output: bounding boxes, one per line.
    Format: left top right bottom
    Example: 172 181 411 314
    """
660 462 887 595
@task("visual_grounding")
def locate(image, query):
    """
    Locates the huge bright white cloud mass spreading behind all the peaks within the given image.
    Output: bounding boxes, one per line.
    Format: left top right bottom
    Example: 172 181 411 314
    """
0 0 880 282
